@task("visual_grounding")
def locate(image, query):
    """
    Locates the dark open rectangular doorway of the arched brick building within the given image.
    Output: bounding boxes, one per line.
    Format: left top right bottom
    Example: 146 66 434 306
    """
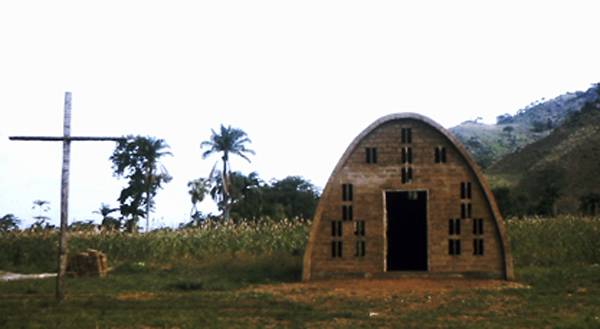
385 191 427 271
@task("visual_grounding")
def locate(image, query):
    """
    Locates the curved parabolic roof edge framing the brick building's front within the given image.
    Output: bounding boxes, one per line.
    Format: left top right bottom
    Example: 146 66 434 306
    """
303 112 514 280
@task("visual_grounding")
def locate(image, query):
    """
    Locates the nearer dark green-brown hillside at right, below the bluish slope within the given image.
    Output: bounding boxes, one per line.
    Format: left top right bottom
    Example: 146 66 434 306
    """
487 89 600 215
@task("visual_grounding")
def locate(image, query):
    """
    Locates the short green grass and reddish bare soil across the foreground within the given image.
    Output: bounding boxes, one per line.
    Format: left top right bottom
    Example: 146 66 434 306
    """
0 265 600 328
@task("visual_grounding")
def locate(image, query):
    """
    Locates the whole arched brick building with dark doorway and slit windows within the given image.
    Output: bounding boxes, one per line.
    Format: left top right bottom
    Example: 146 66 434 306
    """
303 113 513 280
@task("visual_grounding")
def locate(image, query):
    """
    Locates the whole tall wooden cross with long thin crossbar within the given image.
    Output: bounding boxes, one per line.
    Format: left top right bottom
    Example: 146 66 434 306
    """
9 91 126 301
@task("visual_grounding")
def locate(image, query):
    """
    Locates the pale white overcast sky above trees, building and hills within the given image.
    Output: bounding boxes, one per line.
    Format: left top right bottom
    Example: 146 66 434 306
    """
0 0 600 227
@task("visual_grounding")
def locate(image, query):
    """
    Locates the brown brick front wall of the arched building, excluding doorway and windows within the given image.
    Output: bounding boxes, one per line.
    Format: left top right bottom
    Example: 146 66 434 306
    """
304 116 512 279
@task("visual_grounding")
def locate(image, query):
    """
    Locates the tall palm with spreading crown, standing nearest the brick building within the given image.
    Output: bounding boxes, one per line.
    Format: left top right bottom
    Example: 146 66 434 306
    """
200 125 254 220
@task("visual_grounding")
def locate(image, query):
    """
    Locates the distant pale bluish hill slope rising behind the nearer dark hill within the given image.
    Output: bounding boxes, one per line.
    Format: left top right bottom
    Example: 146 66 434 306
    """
450 84 600 168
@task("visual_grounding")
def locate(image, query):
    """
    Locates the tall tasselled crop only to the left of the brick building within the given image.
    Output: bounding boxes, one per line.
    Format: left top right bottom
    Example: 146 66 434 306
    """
0 220 309 272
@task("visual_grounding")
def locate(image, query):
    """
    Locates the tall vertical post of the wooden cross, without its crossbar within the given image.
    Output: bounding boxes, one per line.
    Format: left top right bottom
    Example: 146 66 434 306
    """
56 91 71 301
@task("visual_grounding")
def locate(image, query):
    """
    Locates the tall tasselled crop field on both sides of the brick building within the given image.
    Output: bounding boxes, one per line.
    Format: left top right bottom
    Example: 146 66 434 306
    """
0 216 600 272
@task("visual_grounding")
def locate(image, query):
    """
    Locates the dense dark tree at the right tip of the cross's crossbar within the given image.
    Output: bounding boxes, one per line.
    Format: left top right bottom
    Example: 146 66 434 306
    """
110 136 172 232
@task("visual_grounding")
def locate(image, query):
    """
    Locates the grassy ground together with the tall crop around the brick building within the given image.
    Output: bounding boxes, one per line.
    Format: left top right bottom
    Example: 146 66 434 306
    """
0 217 600 328
